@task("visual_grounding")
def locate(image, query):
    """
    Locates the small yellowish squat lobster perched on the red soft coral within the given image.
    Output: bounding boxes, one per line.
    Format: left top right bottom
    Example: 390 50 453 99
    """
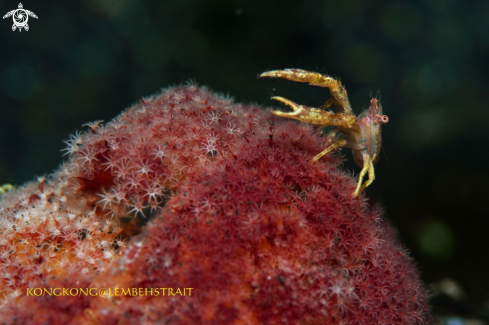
259 69 389 197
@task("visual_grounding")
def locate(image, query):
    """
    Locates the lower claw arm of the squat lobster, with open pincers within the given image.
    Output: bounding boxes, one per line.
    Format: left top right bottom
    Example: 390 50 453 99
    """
272 96 356 129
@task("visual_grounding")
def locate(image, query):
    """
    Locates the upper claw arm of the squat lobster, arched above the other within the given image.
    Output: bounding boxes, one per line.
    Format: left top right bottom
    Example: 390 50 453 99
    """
260 69 353 115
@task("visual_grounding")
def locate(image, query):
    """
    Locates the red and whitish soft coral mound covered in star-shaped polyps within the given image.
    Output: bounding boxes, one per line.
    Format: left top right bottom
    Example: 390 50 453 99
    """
0 85 431 324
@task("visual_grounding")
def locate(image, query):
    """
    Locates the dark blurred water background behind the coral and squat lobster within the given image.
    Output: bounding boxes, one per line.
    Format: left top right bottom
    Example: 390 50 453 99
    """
0 0 489 318
